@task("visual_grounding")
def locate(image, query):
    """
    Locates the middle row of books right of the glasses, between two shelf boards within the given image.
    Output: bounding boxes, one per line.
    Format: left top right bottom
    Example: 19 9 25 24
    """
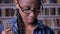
40 8 60 15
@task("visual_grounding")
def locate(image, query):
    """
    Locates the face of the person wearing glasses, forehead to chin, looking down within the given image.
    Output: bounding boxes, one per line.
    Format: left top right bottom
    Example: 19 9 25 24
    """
15 0 40 23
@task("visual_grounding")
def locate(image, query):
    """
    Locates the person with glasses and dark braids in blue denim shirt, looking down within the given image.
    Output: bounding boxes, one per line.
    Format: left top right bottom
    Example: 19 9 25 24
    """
2 0 54 34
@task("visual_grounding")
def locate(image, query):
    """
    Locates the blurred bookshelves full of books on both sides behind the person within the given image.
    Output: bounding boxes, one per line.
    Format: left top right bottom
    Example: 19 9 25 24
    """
0 0 60 34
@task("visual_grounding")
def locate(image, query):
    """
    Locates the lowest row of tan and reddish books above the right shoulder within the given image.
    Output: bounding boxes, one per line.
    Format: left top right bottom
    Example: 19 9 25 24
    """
42 19 60 28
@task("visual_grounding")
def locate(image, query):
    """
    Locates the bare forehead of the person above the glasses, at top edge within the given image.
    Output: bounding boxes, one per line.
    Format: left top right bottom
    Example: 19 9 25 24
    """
18 0 39 6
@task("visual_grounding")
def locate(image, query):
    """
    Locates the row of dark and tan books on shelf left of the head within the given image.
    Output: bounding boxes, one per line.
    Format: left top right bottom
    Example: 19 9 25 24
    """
0 9 15 17
